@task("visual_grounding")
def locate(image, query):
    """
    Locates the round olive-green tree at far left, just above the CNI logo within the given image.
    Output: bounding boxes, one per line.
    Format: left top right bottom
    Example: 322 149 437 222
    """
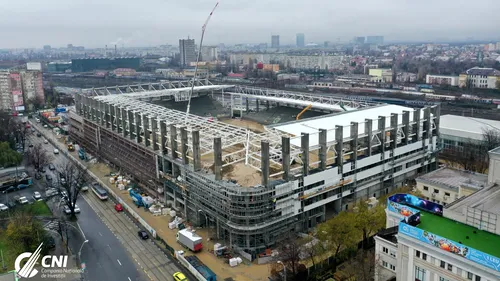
4 212 46 252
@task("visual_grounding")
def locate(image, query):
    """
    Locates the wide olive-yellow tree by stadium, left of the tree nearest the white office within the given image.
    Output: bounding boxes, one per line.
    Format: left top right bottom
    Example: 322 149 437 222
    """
317 212 362 257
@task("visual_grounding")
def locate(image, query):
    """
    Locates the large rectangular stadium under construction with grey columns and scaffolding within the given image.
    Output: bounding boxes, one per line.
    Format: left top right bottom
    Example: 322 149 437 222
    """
70 80 440 257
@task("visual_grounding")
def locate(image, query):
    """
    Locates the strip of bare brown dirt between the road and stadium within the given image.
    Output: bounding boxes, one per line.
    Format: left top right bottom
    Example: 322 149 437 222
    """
90 163 270 281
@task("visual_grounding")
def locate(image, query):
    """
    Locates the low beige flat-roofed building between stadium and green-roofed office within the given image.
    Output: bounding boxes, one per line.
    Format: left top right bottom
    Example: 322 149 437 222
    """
416 167 489 206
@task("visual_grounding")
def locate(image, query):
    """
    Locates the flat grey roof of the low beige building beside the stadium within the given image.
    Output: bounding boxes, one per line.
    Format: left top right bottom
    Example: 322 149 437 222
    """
416 167 488 190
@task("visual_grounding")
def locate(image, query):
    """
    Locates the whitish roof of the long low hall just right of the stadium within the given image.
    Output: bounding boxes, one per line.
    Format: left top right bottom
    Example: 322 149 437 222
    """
439 114 500 140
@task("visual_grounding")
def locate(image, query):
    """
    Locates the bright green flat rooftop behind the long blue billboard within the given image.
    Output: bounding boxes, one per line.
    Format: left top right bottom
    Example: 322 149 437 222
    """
417 211 500 257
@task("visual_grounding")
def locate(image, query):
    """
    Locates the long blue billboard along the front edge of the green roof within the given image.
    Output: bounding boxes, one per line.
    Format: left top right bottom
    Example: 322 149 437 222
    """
399 222 500 272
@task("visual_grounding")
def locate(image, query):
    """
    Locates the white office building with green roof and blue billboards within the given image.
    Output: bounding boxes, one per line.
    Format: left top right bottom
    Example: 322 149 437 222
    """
375 148 500 281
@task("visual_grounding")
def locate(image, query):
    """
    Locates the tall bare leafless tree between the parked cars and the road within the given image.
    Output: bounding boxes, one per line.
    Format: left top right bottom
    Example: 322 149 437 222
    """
57 161 88 219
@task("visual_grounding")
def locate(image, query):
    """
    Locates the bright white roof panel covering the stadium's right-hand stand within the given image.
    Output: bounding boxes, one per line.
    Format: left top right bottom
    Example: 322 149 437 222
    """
274 104 424 147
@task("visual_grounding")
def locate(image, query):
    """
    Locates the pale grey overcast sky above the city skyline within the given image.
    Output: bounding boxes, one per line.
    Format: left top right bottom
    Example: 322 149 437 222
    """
0 0 500 48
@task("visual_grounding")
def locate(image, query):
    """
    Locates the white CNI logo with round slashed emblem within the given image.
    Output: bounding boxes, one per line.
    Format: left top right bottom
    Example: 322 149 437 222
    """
14 243 68 278
